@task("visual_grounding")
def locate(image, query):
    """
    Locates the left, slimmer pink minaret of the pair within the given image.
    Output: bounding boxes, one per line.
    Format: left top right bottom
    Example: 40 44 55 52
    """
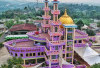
41 0 51 33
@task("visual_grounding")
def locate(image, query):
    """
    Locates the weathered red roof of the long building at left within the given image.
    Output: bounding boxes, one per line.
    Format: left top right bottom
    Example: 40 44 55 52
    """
10 23 37 31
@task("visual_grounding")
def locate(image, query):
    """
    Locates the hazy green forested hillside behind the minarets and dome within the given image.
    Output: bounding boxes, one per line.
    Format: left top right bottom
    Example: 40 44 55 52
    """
0 3 100 25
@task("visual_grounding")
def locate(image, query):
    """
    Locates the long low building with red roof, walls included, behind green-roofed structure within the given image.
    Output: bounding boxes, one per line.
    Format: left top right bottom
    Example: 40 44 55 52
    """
10 23 37 35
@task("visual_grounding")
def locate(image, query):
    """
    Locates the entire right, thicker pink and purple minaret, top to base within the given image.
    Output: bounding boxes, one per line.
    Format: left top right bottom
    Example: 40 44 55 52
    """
47 0 64 67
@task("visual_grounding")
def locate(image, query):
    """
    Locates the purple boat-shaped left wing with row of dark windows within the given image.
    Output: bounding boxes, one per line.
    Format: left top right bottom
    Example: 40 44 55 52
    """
4 39 45 58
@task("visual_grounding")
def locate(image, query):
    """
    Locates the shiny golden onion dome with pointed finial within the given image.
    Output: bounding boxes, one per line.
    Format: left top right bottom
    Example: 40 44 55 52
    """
59 9 74 28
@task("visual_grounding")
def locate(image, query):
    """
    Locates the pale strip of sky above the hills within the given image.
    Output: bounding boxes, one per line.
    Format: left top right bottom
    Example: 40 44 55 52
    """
3 0 100 5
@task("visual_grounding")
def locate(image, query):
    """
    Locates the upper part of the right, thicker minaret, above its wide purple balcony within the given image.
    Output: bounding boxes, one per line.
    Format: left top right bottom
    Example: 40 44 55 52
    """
50 0 62 41
